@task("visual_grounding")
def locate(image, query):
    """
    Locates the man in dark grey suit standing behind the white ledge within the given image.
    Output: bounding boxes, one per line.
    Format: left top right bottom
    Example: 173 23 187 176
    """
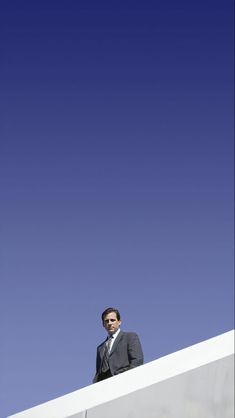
93 308 144 383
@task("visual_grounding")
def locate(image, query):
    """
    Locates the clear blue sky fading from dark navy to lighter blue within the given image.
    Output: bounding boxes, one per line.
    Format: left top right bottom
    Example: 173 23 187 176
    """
0 0 234 418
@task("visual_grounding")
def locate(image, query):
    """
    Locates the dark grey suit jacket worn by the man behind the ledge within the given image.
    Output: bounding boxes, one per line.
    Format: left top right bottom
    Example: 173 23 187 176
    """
93 331 144 383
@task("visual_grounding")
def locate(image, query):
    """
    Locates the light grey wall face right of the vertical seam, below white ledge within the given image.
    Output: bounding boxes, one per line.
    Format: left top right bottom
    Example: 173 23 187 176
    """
87 356 234 418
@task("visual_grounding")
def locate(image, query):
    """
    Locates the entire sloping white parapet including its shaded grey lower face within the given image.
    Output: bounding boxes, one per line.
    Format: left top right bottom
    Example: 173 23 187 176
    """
8 331 234 418
